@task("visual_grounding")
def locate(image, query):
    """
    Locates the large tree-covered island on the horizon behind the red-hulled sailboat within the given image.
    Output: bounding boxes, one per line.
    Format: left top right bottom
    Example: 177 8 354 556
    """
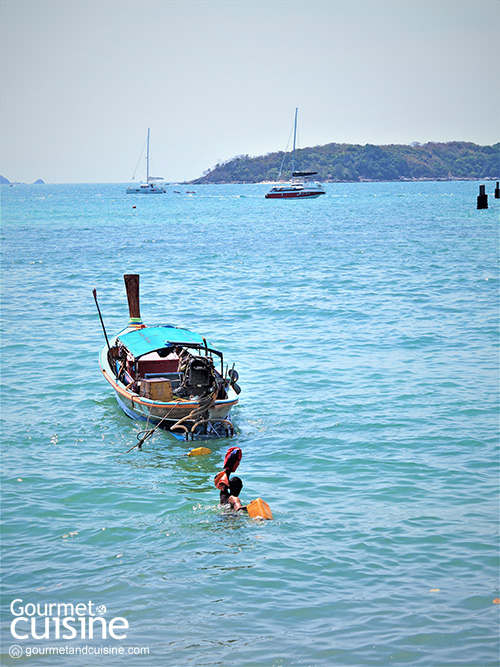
189 141 500 185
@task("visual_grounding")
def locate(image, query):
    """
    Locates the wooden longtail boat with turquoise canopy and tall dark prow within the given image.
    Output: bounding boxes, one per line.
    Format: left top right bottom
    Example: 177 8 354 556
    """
94 274 241 439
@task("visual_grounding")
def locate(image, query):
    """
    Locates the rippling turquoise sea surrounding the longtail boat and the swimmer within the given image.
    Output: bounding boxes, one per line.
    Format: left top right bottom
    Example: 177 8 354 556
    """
1 181 500 667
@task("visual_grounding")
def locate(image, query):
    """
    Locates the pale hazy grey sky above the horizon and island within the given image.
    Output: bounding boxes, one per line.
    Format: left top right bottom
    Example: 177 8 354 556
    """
0 0 500 183
